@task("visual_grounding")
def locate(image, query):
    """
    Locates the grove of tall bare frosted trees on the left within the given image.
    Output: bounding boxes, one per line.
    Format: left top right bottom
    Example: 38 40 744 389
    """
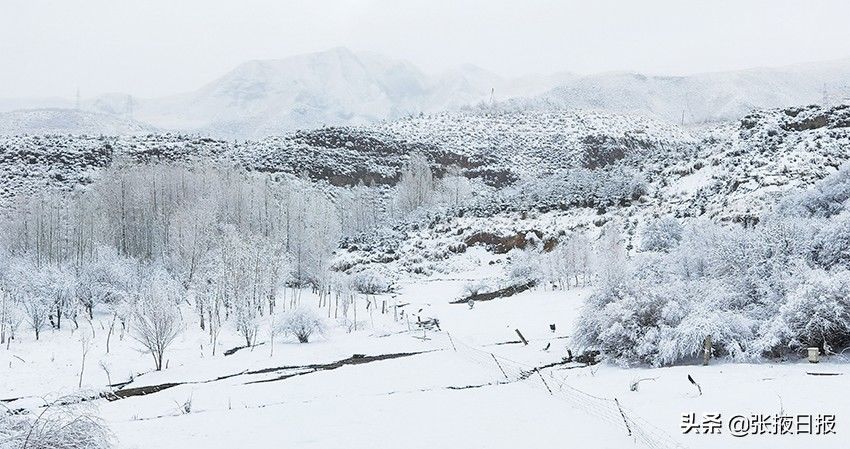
0 165 352 362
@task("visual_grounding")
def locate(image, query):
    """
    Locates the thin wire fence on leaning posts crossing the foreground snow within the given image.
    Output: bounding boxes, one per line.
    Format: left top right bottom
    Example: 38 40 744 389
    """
446 334 685 449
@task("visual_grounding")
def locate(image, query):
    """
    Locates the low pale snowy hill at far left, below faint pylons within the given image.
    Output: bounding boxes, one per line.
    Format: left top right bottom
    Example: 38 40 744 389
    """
0 109 156 135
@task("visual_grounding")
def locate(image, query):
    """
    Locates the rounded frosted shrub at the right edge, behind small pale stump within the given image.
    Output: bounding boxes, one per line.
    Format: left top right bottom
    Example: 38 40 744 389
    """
781 269 850 349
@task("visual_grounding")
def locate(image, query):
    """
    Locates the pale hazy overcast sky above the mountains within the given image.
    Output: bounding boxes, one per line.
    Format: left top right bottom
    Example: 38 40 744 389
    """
0 0 850 98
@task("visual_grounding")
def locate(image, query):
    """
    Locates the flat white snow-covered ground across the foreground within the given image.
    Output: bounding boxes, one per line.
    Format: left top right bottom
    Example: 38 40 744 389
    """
0 264 850 449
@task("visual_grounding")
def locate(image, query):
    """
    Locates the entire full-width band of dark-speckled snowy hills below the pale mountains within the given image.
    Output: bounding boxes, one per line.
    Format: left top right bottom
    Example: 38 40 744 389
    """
0 106 850 221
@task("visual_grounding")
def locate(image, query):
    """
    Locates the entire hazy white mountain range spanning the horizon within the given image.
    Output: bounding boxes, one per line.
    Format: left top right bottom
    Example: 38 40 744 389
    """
0 48 850 139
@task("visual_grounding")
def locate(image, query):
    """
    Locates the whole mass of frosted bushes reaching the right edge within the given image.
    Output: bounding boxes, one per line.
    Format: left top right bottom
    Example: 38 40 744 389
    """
576 167 850 365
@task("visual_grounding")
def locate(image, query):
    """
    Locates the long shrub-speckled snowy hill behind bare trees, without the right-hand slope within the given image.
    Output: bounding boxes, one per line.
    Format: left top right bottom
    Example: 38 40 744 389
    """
0 111 694 208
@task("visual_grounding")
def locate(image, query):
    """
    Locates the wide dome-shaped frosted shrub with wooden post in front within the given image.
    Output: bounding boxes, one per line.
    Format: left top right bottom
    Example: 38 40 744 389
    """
575 273 754 365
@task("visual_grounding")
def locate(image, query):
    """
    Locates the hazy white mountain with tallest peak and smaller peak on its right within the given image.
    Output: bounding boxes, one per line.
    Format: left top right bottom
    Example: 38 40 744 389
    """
127 48 561 138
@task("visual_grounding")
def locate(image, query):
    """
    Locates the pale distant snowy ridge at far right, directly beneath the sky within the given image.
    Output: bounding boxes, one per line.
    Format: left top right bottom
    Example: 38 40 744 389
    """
518 59 850 123
